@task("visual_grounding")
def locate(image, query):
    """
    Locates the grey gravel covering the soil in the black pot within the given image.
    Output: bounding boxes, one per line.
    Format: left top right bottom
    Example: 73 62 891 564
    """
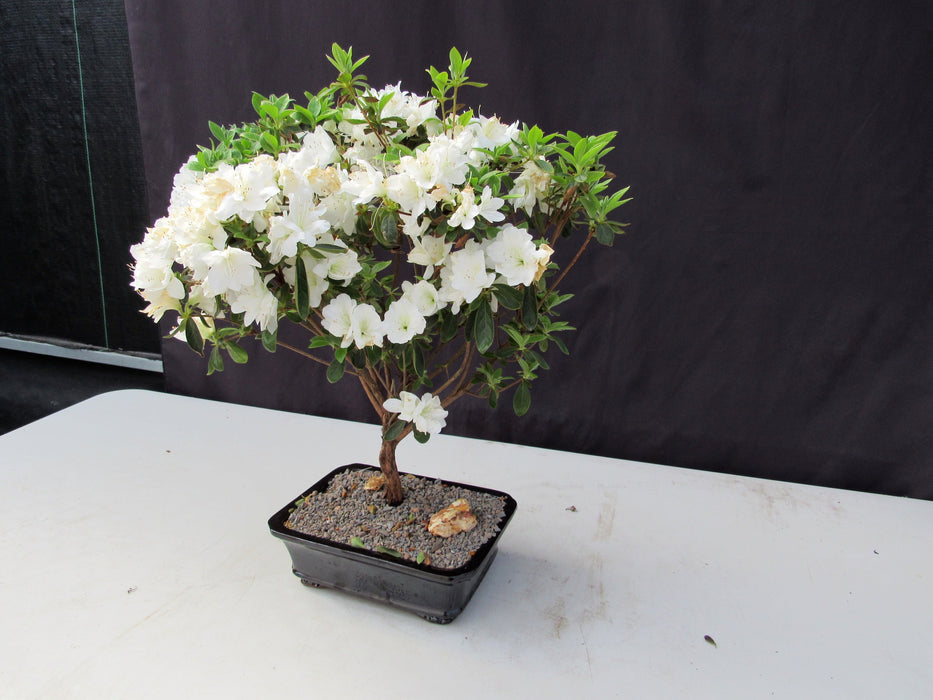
285 469 505 569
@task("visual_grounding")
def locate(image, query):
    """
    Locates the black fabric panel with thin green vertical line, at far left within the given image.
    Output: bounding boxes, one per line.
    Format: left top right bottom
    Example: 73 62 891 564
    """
0 0 159 352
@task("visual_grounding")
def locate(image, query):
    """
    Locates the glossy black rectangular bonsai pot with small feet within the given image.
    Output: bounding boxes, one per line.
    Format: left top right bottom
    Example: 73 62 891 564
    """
269 464 516 624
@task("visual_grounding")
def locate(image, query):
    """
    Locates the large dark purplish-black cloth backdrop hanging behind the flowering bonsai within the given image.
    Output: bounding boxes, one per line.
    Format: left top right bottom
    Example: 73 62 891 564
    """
126 0 933 498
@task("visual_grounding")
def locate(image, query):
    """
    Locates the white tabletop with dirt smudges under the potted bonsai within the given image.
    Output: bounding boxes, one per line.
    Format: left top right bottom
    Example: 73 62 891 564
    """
0 391 933 700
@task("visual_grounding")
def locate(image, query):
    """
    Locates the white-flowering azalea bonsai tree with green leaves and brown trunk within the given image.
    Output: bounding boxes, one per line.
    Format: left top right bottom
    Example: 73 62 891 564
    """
131 44 628 505
